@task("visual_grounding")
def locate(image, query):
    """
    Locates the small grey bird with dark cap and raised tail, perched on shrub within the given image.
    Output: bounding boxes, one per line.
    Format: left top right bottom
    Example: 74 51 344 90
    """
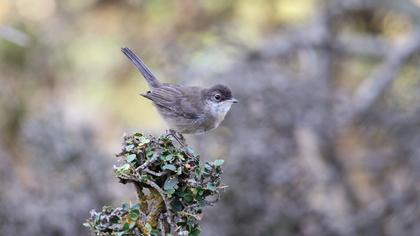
121 48 238 134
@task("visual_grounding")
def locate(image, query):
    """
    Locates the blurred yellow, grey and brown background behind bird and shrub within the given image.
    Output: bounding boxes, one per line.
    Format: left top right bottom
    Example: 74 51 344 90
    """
0 0 420 236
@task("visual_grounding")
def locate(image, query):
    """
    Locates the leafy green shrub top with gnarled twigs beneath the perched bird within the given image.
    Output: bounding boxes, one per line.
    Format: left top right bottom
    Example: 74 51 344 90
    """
84 131 225 236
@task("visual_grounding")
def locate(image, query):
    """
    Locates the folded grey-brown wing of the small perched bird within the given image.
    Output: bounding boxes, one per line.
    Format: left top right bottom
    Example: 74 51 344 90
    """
142 85 198 119
